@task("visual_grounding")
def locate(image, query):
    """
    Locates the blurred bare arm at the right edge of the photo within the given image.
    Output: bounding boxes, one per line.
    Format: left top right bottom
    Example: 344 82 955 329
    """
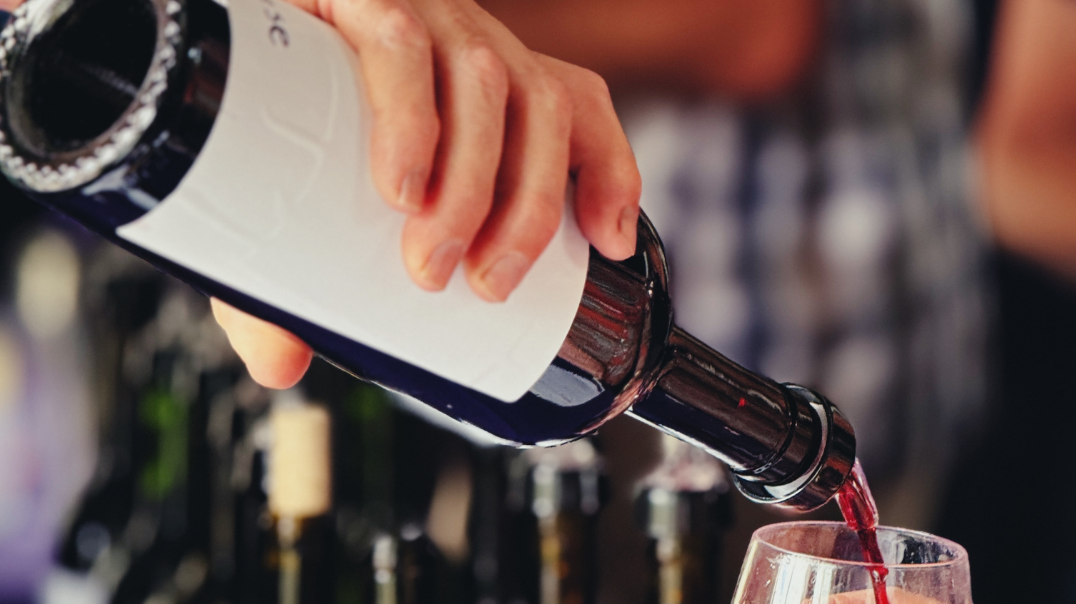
977 0 1076 278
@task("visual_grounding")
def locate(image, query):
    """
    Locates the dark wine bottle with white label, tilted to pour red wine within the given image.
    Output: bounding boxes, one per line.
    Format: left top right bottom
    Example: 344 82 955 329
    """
0 0 855 509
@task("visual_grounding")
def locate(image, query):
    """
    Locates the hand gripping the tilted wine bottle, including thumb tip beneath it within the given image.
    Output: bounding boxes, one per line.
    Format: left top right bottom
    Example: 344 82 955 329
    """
214 0 640 388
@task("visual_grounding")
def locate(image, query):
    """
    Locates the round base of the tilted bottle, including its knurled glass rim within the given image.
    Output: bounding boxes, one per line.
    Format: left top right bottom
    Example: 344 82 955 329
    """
0 0 182 192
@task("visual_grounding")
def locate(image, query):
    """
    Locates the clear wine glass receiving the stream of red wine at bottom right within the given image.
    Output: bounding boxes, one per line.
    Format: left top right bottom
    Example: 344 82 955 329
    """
733 522 972 604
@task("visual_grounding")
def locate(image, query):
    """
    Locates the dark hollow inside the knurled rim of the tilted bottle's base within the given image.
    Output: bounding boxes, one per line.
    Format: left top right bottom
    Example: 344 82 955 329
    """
6 0 157 157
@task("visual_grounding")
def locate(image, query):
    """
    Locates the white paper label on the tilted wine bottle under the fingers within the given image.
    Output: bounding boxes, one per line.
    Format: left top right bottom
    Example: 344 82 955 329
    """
117 0 590 402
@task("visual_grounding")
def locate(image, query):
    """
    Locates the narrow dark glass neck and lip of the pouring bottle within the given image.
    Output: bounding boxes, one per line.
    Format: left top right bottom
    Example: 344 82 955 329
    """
629 327 855 509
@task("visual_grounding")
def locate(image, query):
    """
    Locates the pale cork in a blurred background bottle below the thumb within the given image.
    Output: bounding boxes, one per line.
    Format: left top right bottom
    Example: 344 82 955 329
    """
269 403 331 518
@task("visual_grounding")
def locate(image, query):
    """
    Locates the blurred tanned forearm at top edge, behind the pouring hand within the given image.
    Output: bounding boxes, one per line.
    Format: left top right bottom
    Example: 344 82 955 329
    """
482 0 822 100
